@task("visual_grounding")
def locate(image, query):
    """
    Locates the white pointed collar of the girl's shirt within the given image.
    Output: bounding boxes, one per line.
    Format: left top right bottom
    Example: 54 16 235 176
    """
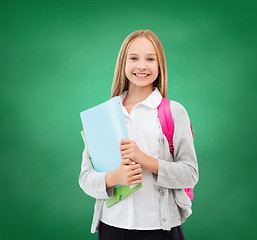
120 87 162 108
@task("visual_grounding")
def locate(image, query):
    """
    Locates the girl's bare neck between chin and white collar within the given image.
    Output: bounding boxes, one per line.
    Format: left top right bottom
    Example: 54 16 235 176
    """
126 84 153 104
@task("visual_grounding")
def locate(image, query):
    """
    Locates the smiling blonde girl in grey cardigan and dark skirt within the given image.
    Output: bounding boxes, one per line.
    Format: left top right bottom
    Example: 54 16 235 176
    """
79 30 198 240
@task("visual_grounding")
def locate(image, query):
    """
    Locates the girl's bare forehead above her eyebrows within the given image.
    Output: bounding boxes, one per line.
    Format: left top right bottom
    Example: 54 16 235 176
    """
128 37 156 54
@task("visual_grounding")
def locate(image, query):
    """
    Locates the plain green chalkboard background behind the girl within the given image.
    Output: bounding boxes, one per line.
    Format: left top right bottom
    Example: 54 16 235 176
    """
0 0 257 240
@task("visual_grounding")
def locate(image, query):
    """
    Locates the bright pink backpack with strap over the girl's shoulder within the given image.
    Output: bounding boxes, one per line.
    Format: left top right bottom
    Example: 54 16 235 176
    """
157 98 194 201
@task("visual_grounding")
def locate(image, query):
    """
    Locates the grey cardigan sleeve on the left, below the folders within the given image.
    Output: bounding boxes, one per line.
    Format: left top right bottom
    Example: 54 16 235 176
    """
79 148 114 199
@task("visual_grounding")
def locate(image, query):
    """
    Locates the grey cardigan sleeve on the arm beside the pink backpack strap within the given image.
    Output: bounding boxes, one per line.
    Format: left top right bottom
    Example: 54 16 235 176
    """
156 101 199 189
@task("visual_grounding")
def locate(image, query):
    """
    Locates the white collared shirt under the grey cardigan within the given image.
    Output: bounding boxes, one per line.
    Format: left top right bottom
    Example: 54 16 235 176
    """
101 88 162 230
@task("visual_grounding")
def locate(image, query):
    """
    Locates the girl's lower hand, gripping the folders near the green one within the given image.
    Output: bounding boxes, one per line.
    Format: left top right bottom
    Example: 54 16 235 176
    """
116 159 143 186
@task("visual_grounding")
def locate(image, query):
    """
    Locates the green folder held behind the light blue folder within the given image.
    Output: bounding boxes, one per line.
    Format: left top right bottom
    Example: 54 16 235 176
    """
81 130 142 208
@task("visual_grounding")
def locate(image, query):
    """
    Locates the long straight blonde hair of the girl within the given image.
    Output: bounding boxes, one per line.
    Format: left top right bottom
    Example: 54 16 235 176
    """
111 29 168 98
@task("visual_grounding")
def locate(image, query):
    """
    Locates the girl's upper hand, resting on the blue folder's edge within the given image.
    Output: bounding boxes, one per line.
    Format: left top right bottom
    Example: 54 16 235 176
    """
120 139 145 165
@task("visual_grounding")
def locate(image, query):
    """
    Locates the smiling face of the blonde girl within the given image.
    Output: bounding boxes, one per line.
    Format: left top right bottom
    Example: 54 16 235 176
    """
125 38 159 87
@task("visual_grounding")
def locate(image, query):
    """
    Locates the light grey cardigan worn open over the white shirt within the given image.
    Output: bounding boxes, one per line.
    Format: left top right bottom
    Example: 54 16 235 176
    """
79 101 199 233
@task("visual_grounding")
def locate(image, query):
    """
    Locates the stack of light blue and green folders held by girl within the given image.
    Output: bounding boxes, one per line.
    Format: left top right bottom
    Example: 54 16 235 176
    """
80 96 142 207
